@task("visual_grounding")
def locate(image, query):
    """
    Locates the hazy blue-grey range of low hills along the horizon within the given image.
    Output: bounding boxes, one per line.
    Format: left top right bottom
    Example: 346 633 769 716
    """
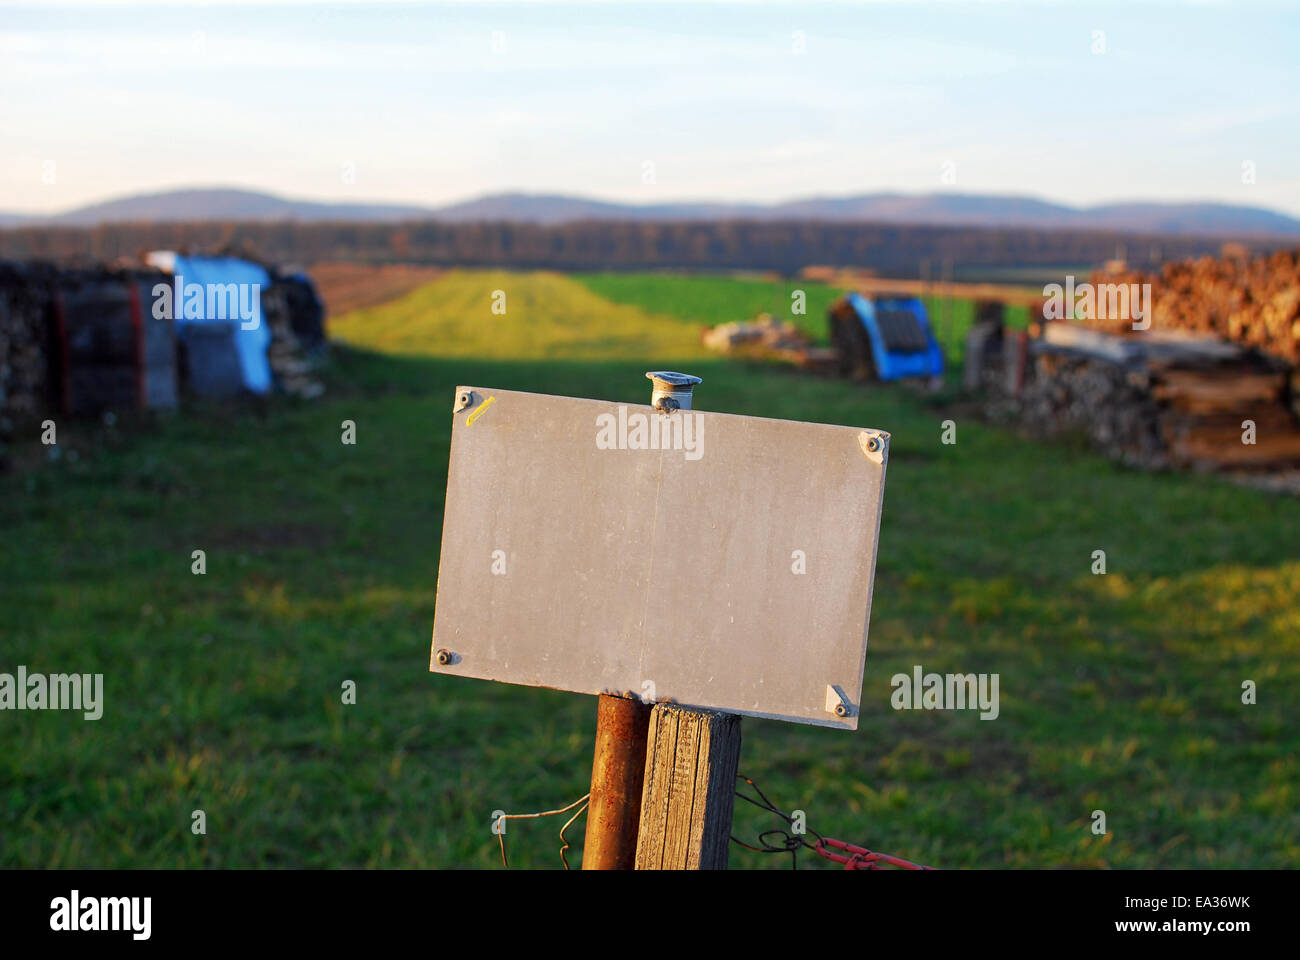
0 189 1300 237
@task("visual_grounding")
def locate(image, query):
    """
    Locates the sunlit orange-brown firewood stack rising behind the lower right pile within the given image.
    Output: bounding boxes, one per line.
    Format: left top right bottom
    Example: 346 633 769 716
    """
1089 250 1300 363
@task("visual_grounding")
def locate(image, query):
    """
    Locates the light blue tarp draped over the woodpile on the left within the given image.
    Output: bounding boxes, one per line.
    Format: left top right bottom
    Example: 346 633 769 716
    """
172 254 270 393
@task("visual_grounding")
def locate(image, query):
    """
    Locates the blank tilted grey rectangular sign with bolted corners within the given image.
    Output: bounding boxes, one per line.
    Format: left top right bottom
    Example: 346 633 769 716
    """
430 386 889 730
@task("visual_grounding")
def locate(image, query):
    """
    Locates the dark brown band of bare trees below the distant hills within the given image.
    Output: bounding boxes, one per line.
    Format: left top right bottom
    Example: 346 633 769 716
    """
0 220 1270 277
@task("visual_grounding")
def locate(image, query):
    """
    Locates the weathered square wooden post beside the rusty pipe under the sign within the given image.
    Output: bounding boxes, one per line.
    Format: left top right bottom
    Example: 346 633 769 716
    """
636 704 740 870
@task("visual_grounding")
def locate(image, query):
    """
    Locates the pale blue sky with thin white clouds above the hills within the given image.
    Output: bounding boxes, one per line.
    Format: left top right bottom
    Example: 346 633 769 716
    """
0 0 1300 216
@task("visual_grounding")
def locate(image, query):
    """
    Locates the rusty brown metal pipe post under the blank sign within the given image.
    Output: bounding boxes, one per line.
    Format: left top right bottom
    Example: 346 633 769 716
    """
582 693 650 870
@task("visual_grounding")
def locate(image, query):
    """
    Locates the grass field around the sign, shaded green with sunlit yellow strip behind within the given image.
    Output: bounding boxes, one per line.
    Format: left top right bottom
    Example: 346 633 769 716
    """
0 265 1300 868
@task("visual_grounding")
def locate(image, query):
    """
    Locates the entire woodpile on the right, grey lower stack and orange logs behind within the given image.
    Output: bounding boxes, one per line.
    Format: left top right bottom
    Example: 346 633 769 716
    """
966 248 1300 478
